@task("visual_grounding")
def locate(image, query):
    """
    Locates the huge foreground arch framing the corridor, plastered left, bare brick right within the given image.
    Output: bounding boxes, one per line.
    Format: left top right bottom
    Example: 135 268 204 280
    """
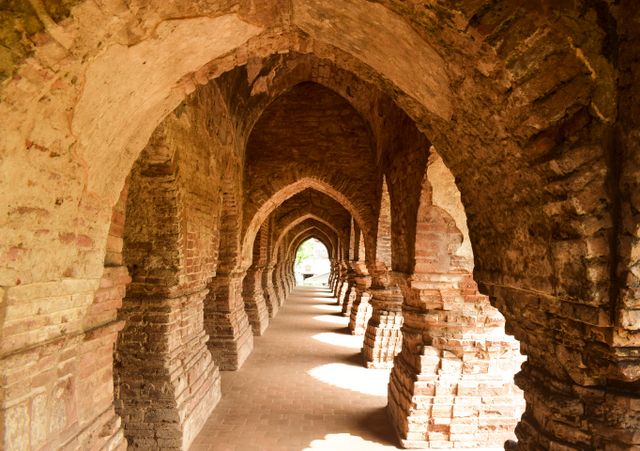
0 1 637 447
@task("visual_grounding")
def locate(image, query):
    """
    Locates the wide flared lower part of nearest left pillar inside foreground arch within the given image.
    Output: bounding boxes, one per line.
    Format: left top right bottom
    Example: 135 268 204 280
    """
114 289 220 449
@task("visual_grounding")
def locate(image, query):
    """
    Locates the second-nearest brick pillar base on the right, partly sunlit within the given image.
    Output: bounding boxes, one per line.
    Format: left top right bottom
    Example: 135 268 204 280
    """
362 268 403 368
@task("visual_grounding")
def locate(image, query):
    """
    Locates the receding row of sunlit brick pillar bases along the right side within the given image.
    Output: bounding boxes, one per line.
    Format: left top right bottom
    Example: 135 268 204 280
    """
329 261 524 448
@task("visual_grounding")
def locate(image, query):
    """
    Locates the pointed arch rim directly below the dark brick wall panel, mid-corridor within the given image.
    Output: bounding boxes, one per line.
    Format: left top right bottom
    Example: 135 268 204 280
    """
242 177 370 265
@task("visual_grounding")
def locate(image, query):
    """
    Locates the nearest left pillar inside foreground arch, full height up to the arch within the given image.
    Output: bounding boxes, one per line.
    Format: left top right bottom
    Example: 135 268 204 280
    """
116 92 229 449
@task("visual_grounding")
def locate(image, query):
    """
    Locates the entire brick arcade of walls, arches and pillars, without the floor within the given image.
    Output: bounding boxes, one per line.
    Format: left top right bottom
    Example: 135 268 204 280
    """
0 0 640 450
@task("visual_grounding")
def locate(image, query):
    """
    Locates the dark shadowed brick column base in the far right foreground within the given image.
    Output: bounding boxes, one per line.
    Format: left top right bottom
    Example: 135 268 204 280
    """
487 286 640 451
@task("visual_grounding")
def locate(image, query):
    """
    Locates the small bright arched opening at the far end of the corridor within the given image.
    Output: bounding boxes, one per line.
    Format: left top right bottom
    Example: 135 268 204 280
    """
294 237 331 286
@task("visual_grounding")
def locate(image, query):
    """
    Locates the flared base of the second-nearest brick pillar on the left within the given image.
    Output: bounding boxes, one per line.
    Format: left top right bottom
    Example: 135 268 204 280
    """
204 271 253 370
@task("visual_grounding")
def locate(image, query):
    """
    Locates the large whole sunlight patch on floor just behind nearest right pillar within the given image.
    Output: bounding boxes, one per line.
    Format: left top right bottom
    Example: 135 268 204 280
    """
307 363 389 396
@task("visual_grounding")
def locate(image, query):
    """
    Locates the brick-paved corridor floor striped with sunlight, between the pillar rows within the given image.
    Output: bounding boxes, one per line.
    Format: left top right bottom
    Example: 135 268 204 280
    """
191 287 398 451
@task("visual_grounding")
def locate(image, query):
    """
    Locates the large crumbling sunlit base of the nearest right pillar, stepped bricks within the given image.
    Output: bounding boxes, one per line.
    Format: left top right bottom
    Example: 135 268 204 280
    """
388 274 524 449
